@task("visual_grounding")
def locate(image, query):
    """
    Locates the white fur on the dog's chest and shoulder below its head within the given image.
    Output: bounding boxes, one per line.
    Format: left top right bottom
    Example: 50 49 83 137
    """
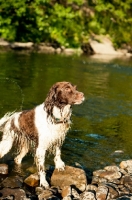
35 104 71 151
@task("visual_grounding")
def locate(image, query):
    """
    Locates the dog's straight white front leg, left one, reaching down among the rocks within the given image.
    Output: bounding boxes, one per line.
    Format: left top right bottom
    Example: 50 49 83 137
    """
35 147 49 188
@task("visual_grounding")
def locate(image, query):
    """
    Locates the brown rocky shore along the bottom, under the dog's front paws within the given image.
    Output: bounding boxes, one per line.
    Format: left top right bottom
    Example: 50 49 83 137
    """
0 160 132 200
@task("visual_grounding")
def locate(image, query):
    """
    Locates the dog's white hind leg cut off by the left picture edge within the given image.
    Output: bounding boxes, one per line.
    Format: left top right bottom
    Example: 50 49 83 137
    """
0 132 14 158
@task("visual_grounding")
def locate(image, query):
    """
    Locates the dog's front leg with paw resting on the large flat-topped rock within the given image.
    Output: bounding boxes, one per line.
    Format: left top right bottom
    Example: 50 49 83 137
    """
54 147 65 170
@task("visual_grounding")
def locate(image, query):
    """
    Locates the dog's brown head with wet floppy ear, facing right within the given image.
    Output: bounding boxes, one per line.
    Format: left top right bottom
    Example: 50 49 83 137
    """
45 82 84 115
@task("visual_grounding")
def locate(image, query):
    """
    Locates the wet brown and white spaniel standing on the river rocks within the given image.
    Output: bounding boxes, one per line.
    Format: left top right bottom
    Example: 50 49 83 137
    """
0 82 84 188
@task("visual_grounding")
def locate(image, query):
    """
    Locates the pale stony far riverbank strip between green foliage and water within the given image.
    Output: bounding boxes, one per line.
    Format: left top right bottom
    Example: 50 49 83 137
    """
0 35 132 57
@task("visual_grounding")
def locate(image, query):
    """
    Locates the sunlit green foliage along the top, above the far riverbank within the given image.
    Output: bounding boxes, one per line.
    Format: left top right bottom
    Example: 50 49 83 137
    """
0 0 132 47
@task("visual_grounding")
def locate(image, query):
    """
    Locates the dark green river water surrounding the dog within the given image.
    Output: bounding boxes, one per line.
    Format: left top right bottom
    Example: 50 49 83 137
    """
0 53 132 175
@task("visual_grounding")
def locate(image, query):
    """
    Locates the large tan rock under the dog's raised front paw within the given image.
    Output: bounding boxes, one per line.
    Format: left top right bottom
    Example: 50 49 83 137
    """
51 166 87 191
